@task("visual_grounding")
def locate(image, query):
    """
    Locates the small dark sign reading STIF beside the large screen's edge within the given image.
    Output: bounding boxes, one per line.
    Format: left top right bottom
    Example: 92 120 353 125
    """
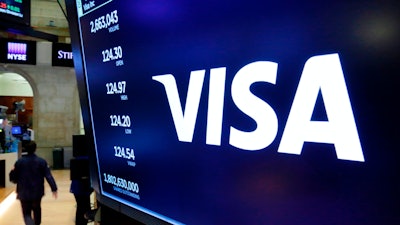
52 43 74 67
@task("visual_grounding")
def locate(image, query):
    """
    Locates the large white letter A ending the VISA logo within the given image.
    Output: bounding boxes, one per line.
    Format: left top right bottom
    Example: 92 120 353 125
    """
278 54 364 162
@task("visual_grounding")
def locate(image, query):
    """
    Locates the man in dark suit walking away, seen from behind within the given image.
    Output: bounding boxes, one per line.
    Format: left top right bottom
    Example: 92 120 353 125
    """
13 141 57 225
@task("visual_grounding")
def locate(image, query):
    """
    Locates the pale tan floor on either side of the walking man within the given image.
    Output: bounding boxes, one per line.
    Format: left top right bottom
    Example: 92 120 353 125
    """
0 170 93 225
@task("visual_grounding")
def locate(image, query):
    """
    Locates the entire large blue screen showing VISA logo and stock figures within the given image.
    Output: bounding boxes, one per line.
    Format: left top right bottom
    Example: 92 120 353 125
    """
69 0 400 225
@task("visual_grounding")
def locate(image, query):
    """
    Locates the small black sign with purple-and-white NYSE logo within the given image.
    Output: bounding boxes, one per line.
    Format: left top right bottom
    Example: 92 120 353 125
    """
0 39 36 65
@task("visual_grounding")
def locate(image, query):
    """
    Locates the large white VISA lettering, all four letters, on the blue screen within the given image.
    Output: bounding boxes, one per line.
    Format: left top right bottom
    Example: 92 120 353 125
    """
153 54 364 162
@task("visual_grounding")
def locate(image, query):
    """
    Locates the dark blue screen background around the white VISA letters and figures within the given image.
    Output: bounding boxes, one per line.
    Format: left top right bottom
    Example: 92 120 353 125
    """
76 0 400 225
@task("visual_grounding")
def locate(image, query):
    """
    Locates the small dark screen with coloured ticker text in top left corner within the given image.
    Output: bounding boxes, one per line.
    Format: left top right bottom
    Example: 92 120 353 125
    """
0 0 31 26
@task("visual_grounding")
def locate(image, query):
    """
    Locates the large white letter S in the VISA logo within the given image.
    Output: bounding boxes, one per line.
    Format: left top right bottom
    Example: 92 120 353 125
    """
229 61 278 150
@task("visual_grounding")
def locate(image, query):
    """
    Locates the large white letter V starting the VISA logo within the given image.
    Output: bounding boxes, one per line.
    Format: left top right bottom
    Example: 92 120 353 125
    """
153 70 205 142
